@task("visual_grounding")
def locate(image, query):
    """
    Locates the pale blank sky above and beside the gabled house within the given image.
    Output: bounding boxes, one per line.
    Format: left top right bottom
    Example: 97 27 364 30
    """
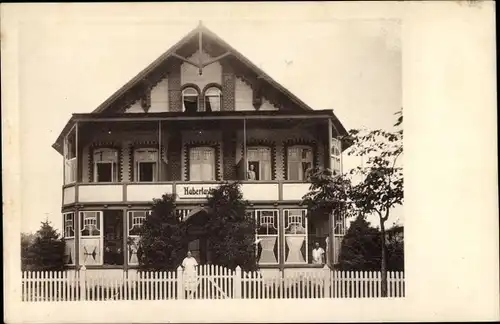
18 3 404 232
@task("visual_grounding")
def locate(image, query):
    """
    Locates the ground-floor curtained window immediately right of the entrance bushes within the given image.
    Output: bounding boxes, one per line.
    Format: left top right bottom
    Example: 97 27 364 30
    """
253 209 279 264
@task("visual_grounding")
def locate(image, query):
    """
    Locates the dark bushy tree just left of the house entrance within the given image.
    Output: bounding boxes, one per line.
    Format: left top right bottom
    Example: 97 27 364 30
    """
137 194 187 271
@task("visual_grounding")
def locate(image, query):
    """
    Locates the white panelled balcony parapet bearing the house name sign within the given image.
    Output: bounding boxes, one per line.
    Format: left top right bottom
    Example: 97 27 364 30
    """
63 181 310 206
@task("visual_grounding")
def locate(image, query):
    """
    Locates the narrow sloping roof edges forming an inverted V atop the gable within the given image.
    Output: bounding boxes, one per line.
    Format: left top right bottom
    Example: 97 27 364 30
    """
92 21 313 114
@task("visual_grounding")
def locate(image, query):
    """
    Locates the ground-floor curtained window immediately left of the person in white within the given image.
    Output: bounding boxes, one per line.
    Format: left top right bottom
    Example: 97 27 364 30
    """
283 209 308 263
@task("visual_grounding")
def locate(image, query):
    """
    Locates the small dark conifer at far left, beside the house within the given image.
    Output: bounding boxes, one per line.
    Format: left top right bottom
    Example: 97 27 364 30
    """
26 221 65 271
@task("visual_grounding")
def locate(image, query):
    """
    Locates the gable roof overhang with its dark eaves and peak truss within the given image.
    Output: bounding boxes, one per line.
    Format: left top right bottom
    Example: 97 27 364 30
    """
92 22 312 114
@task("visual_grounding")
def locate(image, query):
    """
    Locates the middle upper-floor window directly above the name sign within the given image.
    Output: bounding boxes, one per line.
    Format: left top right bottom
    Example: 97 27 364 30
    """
189 147 215 181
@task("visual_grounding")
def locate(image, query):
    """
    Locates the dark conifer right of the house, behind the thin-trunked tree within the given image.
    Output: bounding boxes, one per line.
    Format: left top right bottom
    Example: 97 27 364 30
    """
339 214 381 271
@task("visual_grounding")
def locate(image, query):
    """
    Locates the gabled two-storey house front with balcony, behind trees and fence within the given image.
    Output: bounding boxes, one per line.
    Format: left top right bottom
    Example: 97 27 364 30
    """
53 24 347 271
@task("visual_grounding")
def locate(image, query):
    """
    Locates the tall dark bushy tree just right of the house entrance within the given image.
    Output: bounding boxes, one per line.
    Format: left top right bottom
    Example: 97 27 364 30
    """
206 182 257 271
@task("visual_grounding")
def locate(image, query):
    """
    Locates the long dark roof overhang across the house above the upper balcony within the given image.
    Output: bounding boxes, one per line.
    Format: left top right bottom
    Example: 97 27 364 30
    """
52 109 351 154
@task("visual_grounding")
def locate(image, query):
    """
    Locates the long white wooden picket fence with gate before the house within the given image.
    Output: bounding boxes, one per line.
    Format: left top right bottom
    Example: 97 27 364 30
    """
22 265 405 302
